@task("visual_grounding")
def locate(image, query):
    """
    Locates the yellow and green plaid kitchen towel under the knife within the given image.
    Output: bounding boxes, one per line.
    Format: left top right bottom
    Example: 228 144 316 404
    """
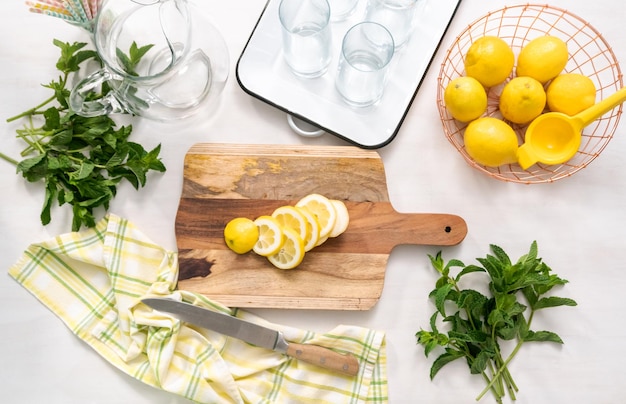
9 214 388 404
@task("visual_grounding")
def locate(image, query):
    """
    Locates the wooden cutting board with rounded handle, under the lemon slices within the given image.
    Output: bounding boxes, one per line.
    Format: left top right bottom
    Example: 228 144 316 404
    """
175 144 467 310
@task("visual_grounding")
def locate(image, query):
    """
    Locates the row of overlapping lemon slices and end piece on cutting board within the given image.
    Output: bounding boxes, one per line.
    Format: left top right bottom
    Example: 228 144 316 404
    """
224 194 350 269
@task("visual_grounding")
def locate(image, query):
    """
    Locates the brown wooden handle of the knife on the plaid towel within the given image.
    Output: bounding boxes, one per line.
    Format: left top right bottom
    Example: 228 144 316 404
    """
287 342 359 376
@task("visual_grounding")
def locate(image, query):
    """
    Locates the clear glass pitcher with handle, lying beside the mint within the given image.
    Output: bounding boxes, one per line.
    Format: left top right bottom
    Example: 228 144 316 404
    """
70 0 229 121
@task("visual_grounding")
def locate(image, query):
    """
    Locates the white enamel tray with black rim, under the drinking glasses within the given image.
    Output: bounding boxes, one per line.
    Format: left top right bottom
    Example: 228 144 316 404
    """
236 0 461 149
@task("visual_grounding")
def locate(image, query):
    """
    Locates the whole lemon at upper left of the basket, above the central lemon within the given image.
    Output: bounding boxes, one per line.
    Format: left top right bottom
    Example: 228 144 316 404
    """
464 35 515 87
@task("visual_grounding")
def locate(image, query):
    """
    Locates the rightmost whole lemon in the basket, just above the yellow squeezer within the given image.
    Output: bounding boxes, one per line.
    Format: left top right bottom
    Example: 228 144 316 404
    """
546 73 596 116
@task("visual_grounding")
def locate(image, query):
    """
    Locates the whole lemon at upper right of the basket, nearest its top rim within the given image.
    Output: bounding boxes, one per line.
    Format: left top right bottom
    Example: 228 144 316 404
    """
515 35 569 83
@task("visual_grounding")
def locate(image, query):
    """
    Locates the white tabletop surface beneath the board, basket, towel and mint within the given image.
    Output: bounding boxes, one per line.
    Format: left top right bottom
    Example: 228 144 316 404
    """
0 0 626 404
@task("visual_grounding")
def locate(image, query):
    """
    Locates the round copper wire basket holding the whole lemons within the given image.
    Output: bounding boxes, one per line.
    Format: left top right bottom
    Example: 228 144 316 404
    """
437 4 622 184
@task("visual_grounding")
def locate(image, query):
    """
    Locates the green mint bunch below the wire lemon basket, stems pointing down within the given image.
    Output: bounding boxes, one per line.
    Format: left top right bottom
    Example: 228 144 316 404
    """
416 241 576 403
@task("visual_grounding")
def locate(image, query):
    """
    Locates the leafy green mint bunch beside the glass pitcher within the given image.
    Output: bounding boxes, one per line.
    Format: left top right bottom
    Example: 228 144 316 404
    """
0 39 165 231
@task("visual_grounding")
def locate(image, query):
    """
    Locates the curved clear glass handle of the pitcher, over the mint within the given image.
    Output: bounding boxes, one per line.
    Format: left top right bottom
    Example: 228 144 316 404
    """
70 69 126 117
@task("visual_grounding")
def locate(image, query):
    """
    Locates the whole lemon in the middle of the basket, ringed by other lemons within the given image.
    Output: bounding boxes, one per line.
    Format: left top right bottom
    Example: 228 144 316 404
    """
500 77 546 124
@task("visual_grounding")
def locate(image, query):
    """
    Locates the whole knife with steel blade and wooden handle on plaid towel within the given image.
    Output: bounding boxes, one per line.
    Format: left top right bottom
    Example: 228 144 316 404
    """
141 298 359 376
